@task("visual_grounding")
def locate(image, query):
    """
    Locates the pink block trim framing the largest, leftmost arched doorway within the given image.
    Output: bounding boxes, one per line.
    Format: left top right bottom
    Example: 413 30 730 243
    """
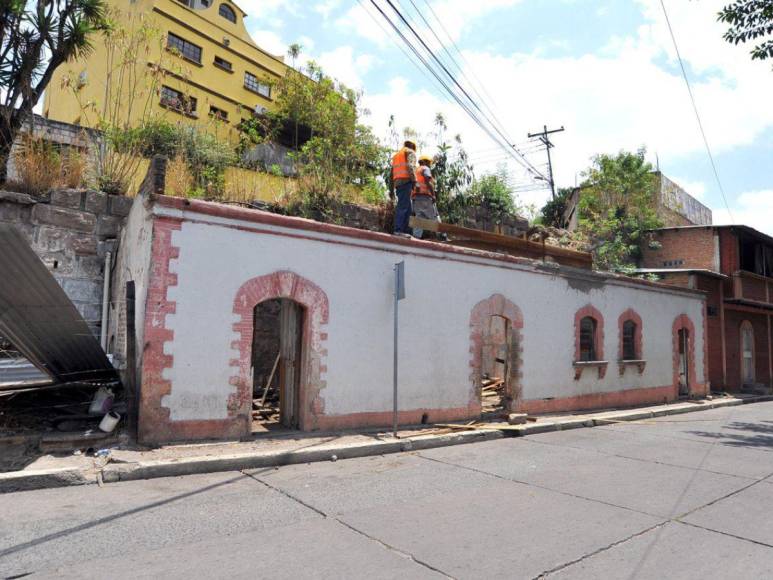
229 271 330 434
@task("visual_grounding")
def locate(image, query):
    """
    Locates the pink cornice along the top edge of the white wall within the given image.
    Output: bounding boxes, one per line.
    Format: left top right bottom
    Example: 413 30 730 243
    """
152 195 706 297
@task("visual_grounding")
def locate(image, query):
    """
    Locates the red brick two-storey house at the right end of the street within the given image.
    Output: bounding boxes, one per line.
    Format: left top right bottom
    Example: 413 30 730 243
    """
640 226 773 391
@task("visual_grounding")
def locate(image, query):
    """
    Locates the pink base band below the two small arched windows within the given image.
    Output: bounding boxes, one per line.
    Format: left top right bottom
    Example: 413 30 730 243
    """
518 385 677 415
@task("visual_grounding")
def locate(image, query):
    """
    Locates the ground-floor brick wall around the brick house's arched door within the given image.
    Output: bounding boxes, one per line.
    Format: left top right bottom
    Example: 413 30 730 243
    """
725 309 770 391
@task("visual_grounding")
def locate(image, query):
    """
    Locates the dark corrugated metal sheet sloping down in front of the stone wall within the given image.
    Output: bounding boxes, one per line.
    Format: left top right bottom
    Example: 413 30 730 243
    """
0 225 116 383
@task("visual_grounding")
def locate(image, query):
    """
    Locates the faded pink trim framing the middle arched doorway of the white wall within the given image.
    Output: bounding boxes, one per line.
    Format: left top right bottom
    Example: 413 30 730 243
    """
470 294 523 410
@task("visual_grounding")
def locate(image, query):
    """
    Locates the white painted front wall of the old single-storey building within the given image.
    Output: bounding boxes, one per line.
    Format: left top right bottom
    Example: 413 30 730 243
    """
154 208 705 420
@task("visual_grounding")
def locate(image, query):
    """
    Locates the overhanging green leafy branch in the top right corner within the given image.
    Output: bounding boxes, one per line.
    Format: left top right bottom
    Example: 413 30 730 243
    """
718 0 773 60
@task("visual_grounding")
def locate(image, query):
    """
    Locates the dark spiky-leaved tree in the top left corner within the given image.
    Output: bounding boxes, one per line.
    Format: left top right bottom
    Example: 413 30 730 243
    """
0 0 108 178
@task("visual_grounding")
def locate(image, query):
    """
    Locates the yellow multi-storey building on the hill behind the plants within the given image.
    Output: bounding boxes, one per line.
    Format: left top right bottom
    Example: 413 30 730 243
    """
44 0 286 138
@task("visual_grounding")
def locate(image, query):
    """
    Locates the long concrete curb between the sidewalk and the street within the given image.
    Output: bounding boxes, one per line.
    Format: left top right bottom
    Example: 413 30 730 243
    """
0 395 773 493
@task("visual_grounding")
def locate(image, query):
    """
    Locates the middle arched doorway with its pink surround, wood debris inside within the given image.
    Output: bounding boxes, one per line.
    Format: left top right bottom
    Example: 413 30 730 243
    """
470 294 523 418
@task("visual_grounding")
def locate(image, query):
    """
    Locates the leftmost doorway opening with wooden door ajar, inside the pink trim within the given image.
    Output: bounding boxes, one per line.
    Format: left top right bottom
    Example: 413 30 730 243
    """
252 298 304 433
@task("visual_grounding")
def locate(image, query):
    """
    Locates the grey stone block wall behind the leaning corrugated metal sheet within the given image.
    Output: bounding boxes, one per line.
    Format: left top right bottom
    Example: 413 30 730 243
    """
0 189 132 334
